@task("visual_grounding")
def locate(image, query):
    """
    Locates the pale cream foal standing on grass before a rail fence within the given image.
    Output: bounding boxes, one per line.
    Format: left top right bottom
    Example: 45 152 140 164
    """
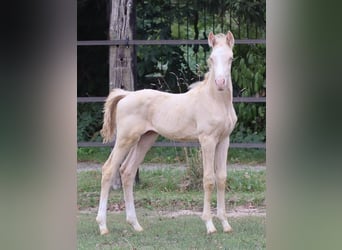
96 31 237 234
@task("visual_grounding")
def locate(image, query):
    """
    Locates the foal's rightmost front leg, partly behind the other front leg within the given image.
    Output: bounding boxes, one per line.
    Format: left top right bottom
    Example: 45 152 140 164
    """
215 137 232 233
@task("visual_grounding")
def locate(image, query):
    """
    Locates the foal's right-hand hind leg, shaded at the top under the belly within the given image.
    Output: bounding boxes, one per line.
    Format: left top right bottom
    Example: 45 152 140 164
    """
120 131 158 231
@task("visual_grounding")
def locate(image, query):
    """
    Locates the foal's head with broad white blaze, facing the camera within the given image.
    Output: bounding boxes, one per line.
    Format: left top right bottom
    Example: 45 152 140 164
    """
208 31 234 91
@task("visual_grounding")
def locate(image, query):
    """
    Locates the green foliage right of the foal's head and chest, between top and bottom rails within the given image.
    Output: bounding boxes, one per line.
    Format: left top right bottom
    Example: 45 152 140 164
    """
231 45 266 142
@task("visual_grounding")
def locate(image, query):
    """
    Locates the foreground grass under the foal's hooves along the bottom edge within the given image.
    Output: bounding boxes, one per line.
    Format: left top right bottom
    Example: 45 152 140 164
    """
77 211 266 250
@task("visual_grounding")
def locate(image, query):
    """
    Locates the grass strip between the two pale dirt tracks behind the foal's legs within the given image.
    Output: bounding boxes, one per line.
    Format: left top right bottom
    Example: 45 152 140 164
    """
77 169 266 211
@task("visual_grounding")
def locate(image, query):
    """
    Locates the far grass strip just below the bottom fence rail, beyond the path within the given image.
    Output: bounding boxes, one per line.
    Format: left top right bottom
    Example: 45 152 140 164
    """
77 147 266 165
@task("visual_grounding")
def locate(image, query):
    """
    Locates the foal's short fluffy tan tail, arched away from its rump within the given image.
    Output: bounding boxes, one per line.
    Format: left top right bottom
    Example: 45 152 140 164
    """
100 89 129 143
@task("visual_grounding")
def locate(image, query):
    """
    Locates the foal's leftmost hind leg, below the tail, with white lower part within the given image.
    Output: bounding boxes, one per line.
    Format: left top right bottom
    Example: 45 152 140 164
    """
96 140 135 234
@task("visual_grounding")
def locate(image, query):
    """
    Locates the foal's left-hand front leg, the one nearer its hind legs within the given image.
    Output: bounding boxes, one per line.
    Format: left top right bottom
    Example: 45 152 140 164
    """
199 136 216 234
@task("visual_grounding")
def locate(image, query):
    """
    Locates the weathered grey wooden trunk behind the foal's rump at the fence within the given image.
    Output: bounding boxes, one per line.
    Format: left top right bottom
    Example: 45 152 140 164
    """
109 0 136 189
